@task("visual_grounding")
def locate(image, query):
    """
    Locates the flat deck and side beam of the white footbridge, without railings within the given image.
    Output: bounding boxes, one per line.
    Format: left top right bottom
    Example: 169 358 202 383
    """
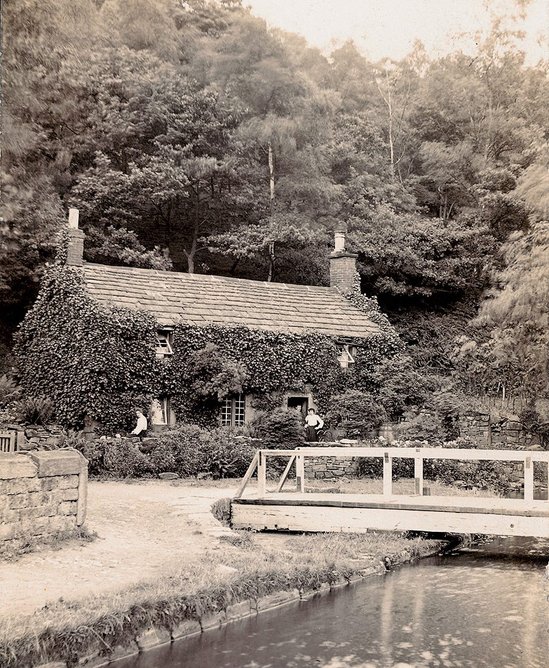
232 493 549 538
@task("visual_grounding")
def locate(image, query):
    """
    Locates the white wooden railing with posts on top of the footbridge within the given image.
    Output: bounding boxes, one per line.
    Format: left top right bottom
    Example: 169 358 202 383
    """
235 446 549 502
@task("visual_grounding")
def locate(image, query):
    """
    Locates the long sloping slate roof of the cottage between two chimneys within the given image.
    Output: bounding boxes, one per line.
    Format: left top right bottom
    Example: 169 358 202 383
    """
83 263 380 338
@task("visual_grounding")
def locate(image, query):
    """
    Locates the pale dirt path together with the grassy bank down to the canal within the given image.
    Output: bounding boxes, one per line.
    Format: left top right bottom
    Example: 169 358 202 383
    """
0 481 446 668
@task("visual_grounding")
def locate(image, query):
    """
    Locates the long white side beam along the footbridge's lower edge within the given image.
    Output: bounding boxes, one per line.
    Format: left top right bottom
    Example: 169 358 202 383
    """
232 502 549 538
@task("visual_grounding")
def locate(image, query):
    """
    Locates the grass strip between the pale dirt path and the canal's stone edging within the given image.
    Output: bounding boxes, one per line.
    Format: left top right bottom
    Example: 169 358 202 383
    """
0 532 441 668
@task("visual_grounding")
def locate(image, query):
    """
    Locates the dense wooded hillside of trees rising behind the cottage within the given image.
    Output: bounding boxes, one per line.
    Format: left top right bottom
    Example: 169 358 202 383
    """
4 0 549 408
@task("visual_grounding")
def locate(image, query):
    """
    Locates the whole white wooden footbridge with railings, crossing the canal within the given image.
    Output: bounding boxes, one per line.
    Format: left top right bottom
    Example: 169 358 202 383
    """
231 447 549 538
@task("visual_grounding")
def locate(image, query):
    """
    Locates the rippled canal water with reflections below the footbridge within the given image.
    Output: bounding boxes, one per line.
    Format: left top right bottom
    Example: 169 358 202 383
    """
116 539 549 668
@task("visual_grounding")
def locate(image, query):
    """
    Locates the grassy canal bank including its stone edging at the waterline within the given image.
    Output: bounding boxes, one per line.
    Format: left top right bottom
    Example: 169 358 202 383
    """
0 534 445 668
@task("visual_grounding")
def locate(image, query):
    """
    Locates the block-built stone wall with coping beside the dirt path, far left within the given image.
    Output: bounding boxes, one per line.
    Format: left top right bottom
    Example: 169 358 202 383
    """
0 449 88 553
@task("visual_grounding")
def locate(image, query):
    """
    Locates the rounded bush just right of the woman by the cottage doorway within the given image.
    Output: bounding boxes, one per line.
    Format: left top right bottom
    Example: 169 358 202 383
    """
326 390 387 439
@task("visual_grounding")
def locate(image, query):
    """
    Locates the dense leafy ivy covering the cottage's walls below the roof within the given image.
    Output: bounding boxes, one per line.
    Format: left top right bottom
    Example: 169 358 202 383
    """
16 266 401 431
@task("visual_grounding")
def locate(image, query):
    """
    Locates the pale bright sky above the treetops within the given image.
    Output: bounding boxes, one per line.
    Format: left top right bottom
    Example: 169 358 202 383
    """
243 0 549 64
